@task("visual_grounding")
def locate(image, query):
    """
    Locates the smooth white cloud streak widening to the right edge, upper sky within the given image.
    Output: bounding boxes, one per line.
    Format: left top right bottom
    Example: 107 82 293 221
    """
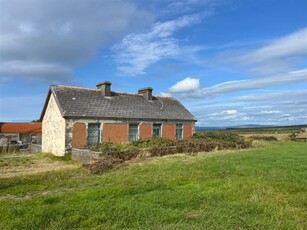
213 28 307 76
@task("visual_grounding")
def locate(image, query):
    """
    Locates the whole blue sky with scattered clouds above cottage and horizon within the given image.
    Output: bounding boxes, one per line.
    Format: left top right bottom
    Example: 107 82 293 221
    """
0 0 307 127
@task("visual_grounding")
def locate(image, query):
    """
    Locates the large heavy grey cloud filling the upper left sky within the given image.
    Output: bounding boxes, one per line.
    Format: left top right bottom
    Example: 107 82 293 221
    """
0 0 153 81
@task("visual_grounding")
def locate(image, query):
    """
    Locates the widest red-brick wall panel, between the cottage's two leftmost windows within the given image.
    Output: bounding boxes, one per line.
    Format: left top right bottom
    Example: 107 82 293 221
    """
102 123 128 143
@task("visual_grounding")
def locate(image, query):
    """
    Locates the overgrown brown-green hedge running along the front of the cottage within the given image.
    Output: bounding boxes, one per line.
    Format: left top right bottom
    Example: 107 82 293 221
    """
84 132 251 173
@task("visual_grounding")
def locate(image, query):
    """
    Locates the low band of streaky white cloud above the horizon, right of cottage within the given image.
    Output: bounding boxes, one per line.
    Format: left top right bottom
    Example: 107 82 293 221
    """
189 90 307 126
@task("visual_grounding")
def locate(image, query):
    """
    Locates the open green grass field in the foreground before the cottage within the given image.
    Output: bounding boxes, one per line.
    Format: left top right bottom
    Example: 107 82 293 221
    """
0 142 307 229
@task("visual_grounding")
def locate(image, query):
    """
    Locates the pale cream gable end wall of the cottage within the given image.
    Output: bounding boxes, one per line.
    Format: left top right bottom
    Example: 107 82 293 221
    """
42 94 66 156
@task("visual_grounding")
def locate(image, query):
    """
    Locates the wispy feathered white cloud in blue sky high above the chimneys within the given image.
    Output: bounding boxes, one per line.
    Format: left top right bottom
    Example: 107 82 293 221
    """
112 15 200 75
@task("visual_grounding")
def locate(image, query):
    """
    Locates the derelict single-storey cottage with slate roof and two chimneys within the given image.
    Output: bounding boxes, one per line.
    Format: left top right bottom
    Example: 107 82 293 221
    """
40 81 196 156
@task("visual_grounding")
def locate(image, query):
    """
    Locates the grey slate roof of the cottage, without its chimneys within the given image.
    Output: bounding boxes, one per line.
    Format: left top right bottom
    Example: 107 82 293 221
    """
41 85 196 121
